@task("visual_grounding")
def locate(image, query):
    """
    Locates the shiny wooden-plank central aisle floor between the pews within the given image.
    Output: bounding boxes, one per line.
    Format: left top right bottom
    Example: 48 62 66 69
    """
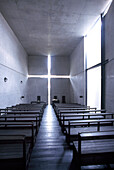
29 106 72 170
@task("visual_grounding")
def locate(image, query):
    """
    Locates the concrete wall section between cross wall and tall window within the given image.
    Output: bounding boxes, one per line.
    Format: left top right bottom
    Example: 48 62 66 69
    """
70 39 84 104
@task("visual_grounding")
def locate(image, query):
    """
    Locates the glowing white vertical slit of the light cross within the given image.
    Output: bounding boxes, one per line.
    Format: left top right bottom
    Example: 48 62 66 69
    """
48 54 51 105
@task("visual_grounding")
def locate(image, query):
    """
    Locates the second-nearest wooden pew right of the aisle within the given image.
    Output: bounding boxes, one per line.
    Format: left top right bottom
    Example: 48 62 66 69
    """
66 118 114 144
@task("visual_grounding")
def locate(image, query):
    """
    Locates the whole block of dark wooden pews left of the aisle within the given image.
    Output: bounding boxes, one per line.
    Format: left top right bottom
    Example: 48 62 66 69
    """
0 103 46 170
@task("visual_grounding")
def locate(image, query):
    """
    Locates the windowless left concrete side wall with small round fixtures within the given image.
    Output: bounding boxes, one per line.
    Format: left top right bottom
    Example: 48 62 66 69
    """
0 13 28 108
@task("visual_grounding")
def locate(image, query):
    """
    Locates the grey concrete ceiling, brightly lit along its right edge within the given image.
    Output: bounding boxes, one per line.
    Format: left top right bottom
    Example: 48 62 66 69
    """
0 0 109 56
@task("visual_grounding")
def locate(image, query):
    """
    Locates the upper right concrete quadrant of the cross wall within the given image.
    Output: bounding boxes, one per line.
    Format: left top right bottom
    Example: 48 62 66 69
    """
51 56 70 75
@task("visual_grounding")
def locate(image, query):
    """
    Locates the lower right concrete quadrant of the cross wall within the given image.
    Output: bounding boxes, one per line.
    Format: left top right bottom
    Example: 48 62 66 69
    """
51 78 70 103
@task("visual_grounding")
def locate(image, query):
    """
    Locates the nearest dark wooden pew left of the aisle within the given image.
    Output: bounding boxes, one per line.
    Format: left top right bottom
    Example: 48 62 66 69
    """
0 135 31 170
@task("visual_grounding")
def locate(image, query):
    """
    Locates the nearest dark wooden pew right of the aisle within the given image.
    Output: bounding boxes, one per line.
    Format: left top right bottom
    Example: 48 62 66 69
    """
73 131 114 169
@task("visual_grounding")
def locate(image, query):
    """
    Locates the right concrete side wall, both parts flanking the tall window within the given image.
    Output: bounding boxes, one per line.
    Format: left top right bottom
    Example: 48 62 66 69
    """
70 2 114 109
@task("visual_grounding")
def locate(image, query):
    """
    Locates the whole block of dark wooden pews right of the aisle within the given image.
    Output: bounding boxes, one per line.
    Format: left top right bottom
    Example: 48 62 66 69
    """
54 103 114 169
